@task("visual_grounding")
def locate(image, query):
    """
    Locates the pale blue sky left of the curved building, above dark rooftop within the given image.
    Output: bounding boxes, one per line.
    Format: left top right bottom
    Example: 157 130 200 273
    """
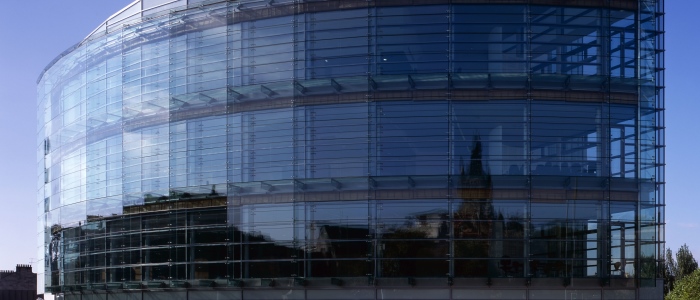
0 0 133 270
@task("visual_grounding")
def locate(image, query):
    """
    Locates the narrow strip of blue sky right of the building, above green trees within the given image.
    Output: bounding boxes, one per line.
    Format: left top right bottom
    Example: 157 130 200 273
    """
666 1 700 258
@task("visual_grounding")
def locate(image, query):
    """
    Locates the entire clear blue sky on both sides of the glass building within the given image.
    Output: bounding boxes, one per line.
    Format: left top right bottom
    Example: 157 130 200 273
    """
0 0 700 270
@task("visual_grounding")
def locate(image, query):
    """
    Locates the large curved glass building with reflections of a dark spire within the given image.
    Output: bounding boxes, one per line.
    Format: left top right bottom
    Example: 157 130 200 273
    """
36 0 665 299
